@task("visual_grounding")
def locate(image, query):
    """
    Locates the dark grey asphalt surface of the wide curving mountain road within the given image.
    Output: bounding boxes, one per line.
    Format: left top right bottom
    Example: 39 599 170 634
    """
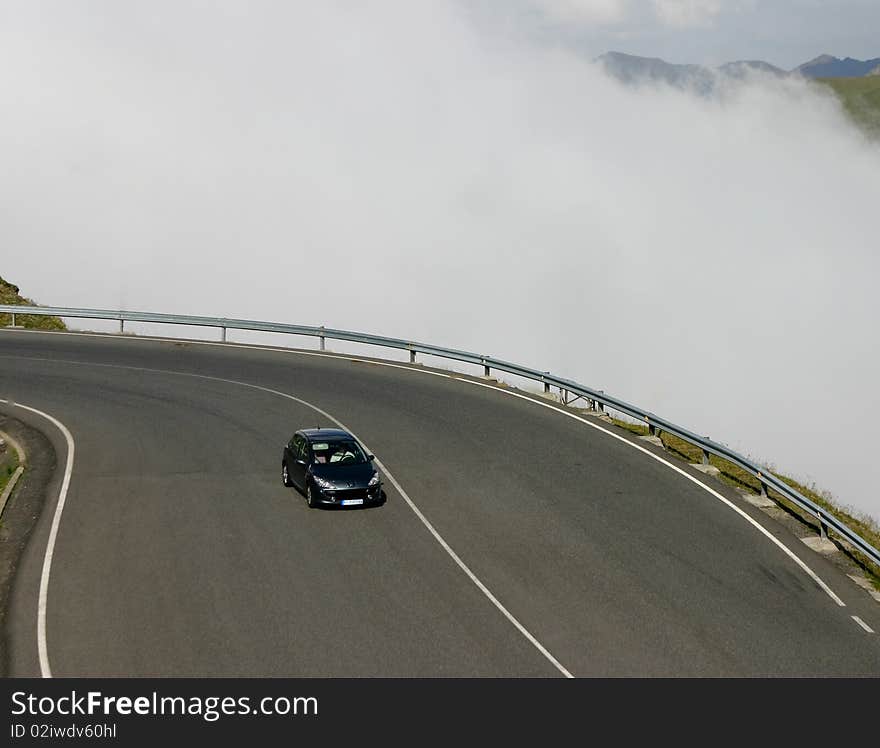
0 331 880 677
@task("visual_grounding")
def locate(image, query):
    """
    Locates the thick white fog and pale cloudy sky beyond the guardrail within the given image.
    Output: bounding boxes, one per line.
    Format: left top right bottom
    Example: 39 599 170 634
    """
0 0 880 517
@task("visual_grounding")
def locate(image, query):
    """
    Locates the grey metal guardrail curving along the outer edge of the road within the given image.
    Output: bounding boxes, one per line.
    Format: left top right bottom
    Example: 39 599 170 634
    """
0 304 880 566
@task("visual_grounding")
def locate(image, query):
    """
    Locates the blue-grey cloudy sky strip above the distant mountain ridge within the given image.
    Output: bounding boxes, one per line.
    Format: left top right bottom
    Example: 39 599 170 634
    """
482 0 880 70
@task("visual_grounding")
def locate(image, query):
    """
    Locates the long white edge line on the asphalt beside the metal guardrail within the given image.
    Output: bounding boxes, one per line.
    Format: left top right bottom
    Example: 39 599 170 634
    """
0 331 846 644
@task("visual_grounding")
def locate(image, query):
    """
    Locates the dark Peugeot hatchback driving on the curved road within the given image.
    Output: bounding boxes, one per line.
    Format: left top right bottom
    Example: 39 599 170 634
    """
281 429 385 507
